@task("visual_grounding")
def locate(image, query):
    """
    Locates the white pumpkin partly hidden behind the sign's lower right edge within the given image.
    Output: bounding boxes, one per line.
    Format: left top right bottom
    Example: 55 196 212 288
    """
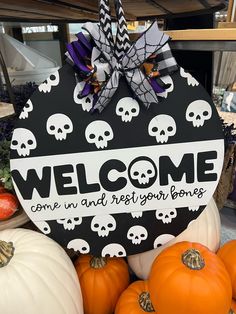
128 198 221 280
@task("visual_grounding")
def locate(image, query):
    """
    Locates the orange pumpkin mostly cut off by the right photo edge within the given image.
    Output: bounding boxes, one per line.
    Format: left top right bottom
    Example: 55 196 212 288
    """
217 240 236 299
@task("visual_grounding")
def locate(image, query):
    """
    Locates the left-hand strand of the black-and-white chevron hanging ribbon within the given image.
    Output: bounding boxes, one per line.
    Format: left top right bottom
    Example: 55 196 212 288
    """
99 0 113 43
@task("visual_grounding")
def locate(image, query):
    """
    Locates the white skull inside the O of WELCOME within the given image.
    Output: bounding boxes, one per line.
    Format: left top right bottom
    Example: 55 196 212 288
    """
130 160 156 184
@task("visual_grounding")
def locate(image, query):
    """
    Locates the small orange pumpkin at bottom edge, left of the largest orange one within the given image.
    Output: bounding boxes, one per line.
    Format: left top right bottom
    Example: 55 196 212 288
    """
115 280 157 314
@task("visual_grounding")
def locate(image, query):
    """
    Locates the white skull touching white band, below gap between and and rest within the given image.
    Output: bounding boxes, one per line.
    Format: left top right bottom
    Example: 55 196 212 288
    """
91 215 116 237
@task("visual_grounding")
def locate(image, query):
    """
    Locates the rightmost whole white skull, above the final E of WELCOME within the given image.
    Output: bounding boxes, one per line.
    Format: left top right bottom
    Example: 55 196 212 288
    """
186 100 212 128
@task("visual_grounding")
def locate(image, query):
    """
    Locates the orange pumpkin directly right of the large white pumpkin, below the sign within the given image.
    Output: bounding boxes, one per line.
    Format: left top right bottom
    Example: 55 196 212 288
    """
75 255 129 314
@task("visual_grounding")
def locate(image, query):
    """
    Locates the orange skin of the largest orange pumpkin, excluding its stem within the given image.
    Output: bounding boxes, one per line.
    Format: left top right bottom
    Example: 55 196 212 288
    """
148 242 232 314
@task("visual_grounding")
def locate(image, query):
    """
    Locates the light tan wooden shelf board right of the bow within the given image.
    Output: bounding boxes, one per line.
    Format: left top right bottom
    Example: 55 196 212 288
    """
165 28 236 41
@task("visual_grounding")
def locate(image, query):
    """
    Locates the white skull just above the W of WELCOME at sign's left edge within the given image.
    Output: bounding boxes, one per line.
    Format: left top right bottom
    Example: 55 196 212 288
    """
11 128 37 157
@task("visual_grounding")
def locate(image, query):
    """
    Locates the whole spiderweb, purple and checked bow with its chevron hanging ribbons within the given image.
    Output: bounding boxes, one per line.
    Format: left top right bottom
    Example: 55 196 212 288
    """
67 0 177 112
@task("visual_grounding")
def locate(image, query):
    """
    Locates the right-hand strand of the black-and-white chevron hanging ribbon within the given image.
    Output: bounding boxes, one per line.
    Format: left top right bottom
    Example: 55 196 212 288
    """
115 0 130 60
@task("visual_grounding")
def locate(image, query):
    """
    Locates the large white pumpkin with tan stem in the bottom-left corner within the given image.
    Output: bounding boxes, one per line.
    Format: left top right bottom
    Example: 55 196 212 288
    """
0 228 83 314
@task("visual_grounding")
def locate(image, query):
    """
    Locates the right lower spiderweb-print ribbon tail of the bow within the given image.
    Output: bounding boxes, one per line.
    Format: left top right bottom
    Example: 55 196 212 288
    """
126 69 158 109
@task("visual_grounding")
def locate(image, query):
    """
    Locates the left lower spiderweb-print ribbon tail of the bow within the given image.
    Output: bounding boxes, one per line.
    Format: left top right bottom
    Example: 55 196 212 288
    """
92 70 120 112
